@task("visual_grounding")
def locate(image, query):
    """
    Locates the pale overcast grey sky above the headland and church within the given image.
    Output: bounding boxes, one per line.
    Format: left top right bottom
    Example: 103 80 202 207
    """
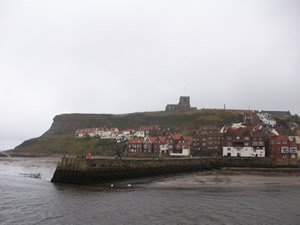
0 0 300 150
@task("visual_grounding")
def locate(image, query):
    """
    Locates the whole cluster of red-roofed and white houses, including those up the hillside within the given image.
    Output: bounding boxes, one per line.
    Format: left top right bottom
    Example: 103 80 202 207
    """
75 110 300 159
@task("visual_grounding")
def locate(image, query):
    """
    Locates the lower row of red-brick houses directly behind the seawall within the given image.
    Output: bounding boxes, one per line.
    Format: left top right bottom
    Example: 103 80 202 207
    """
127 124 300 159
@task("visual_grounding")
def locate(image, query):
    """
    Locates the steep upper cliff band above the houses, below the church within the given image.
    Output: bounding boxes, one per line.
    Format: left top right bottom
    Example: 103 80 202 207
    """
43 110 238 136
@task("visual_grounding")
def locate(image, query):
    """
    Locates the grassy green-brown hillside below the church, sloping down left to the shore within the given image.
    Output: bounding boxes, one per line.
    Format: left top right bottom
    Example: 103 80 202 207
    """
12 110 241 155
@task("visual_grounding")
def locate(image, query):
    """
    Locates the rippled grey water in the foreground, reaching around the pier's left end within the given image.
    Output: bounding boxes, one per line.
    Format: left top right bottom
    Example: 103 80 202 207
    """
0 158 300 224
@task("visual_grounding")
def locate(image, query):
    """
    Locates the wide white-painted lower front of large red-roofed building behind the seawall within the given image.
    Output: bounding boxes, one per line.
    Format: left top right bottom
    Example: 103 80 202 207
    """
223 146 265 157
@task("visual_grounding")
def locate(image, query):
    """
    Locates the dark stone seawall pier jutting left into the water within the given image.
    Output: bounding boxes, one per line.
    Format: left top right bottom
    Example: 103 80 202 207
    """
51 158 284 184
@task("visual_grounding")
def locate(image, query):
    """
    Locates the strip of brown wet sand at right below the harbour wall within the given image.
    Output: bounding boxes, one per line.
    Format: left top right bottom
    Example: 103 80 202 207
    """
153 168 300 188
